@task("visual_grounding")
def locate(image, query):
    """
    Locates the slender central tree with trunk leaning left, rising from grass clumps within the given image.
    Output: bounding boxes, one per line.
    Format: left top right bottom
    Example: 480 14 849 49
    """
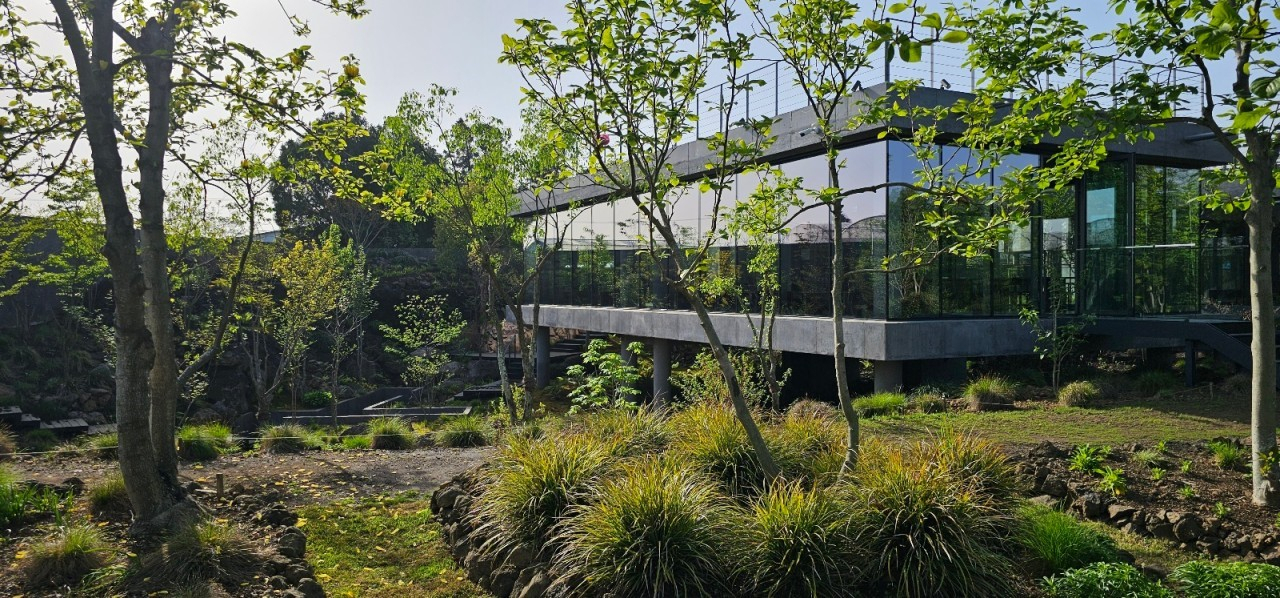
502 0 778 478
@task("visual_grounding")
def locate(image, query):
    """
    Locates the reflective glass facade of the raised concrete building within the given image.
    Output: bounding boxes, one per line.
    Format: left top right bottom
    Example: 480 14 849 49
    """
531 141 1248 319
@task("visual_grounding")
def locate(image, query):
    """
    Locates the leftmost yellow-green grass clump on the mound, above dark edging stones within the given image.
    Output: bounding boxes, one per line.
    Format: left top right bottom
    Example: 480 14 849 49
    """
479 434 613 545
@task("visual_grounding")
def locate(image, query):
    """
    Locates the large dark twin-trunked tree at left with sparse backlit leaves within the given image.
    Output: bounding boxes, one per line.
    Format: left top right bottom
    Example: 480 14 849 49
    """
0 0 364 531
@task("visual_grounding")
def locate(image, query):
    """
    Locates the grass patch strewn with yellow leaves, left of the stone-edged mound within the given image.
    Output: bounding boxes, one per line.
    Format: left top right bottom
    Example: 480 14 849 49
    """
300 493 489 598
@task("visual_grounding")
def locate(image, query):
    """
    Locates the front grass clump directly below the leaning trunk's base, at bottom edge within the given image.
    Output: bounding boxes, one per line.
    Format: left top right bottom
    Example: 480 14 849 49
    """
739 484 860 598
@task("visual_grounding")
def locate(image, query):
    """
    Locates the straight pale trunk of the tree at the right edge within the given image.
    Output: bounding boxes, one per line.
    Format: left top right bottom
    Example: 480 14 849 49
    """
1244 170 1280 506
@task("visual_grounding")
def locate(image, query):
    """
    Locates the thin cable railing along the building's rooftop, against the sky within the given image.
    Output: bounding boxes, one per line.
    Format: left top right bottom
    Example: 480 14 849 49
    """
694 44 1204 138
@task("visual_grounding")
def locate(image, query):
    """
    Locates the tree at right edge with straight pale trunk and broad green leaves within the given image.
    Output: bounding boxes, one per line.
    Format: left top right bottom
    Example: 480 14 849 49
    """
970 0 1280 505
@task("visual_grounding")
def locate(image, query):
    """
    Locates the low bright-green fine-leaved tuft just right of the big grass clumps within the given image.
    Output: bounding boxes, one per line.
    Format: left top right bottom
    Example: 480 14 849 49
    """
1016 505 1120 575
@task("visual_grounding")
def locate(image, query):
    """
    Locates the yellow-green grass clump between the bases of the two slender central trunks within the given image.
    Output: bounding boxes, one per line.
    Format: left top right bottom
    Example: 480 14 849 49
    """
764 411 847 481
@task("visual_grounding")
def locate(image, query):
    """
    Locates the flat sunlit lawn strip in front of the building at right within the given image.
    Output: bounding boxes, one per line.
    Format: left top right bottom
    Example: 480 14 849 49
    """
863 397 1249 444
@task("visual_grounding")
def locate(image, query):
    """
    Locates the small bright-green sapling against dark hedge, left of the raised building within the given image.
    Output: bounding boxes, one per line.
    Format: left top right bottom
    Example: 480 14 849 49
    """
378 296 466 402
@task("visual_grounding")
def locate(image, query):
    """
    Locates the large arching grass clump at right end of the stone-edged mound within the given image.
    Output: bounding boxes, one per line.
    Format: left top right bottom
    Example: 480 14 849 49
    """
850 448 1014 597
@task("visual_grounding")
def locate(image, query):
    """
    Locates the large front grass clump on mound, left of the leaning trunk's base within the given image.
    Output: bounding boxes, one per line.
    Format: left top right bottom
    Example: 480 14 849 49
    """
558 457 741 595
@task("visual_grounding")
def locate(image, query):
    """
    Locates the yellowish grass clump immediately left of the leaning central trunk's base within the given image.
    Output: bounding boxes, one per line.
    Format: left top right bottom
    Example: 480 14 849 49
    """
668 402 764 494
